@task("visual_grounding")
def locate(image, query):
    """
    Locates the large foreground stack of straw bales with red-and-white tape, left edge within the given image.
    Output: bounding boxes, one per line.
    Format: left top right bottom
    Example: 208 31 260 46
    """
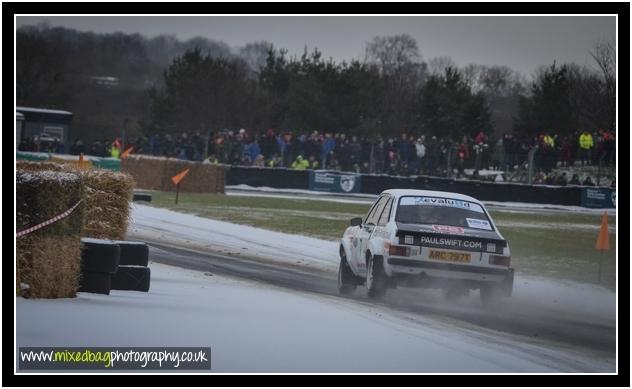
16 161 134 298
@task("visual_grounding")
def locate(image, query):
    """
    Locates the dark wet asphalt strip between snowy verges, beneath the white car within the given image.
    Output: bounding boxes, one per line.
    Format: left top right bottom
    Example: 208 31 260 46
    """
148 242 616 360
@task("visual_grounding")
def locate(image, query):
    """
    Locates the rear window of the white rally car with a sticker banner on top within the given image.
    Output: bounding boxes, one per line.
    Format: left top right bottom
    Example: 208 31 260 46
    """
395 196 493 231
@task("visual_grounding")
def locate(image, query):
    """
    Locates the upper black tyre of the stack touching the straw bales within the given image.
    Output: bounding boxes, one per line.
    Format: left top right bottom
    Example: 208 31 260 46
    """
81 238 121 274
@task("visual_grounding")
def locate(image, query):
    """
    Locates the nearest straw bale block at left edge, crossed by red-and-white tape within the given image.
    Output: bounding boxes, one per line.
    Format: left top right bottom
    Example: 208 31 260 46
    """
16 170 85 298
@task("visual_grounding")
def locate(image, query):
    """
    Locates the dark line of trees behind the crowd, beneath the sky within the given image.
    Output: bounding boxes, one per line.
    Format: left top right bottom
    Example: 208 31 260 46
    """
16 25 616 141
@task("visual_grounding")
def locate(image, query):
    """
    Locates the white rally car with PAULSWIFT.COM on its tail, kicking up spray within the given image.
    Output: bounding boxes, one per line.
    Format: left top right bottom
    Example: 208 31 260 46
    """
338 189 514 303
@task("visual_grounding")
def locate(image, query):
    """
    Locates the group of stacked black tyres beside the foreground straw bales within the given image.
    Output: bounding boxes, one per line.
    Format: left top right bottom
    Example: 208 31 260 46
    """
78 238 151 294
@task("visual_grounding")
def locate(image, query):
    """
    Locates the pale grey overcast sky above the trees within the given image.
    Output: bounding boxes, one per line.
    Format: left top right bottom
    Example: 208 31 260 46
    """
16 16 616 75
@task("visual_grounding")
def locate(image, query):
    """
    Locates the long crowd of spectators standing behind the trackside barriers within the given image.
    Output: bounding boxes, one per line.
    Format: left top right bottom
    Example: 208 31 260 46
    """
19 129 615 183
